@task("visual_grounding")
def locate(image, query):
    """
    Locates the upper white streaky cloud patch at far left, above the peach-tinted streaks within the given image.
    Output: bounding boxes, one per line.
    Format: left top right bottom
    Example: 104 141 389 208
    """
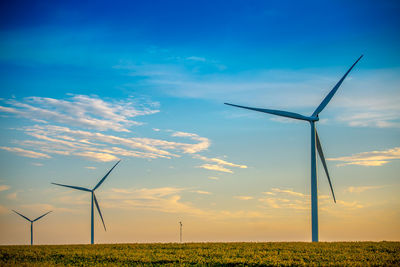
0 95 159 132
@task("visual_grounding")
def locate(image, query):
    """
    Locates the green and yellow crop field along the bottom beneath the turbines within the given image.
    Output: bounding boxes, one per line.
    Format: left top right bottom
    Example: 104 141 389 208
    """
0 242 400 266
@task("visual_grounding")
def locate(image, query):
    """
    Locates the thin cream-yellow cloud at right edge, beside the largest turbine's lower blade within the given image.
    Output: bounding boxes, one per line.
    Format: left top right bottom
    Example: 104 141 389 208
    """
328 147 400 166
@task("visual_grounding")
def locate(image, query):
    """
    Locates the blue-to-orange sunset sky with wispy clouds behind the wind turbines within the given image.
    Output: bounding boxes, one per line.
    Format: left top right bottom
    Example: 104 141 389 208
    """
0 0 400 244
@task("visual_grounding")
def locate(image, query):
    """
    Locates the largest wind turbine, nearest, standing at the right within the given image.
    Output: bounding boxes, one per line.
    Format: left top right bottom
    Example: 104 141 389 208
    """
225 55 363 242
